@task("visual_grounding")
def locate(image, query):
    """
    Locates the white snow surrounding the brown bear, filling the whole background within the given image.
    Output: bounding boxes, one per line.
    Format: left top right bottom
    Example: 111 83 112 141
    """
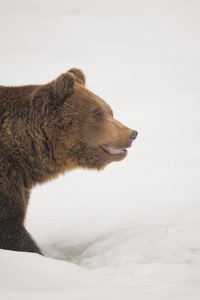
0 0 200 300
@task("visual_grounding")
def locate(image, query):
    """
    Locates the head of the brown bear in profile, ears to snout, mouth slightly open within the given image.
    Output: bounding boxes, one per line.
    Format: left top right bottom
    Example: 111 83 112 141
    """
32 69 137 171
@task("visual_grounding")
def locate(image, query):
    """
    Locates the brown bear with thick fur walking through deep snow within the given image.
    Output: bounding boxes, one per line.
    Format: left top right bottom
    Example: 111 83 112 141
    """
0 69 137 254
